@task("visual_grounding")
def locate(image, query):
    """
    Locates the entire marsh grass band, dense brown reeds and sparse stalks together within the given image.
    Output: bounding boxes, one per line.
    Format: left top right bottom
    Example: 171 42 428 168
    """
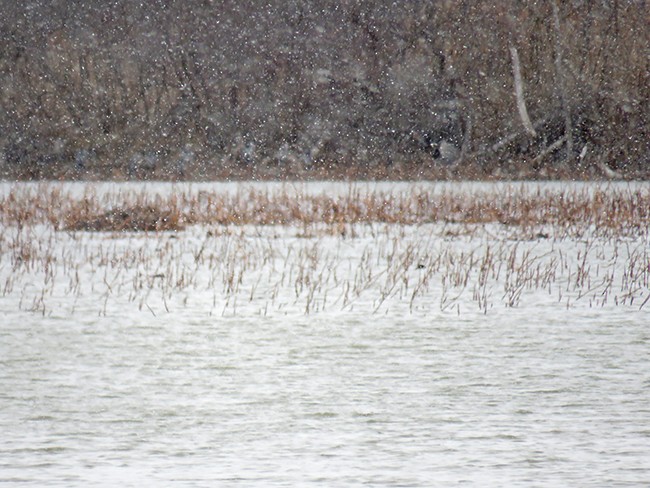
0 186 650 315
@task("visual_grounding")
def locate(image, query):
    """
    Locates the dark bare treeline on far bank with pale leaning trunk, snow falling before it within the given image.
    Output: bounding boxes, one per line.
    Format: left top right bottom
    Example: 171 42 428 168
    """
0 0 650 179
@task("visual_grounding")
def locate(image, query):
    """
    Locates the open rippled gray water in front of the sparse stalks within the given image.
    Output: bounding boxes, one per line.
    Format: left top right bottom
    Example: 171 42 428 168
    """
0 309 650 487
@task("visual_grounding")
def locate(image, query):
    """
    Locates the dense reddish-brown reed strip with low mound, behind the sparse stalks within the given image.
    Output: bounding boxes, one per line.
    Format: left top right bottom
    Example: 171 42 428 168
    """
0 185 650 235
